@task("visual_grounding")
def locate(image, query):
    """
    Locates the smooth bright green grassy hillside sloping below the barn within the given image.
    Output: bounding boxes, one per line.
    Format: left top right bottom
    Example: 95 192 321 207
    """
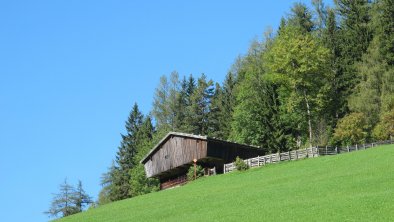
59 145 394 222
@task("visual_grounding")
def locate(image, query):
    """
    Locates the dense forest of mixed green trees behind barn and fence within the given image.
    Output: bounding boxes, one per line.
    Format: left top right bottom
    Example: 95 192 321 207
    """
76 0 394 215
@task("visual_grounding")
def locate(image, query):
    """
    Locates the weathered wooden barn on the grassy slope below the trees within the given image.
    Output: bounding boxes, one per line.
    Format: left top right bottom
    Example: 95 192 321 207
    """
141 132 264 189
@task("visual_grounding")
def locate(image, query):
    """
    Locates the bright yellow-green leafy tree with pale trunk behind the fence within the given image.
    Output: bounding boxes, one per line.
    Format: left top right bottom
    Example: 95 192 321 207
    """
265 26 332 147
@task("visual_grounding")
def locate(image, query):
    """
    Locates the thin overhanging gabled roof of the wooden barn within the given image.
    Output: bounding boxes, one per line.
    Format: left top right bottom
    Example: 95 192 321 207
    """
140 132 260 164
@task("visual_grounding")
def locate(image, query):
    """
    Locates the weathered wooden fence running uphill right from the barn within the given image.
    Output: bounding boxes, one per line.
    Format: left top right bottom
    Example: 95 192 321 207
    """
223 140 394 173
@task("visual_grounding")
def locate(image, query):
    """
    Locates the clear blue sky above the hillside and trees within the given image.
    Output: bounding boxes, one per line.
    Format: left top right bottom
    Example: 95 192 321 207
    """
0 0 318 222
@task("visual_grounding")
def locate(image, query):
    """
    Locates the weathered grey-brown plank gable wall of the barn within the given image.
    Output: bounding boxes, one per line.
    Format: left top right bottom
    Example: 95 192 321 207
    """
145 136 207 177
